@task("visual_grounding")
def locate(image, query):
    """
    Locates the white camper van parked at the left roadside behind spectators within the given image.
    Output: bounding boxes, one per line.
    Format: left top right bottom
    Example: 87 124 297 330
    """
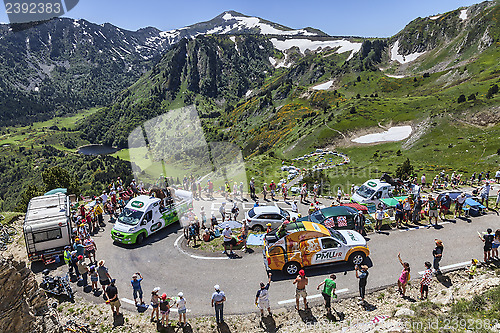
23 193 71 264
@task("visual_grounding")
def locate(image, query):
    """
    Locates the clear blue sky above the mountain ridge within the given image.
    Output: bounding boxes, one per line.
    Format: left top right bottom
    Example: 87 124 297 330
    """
0 0 479 37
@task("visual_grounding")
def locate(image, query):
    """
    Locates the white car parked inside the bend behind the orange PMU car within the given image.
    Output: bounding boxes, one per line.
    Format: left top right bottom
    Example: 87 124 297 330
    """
245 206 298 232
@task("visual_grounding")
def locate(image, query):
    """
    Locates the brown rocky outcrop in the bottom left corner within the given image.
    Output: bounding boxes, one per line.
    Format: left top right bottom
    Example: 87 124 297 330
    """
0 253 53 332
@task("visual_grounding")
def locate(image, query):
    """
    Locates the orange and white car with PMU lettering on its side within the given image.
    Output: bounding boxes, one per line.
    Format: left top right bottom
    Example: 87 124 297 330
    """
264 221 370 275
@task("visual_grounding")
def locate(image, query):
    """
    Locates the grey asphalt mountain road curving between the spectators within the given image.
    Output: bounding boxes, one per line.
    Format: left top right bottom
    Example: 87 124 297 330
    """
82 193 499 315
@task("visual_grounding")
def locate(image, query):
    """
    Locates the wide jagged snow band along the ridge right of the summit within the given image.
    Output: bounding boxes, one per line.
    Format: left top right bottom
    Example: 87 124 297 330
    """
271 38 361 60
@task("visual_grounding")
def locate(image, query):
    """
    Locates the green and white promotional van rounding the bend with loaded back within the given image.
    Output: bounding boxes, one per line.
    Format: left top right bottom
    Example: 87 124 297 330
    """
111 190 193 244
